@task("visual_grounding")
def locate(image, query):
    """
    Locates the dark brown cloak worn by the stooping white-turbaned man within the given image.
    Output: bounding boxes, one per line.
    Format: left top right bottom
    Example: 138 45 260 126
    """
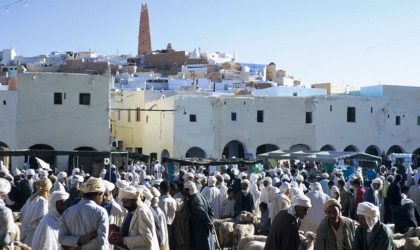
264 210 300 250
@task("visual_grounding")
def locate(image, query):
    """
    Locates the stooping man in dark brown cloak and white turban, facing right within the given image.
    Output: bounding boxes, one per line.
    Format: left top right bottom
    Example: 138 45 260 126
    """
264 194 312 250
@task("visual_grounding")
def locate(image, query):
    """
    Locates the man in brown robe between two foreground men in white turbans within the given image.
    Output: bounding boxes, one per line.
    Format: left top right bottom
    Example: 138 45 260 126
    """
314 199 356 250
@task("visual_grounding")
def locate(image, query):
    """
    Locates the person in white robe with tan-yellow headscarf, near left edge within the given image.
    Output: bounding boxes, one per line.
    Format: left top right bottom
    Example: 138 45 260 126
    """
20 179 52 246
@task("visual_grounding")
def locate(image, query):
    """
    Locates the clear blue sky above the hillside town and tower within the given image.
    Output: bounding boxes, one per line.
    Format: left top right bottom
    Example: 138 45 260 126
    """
0 0 420 86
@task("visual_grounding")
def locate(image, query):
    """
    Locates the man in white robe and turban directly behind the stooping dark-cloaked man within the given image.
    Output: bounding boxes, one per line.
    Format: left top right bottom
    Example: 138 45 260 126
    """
300 182 330 232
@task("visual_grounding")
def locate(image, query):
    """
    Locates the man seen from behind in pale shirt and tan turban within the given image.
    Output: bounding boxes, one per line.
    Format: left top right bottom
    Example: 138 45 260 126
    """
58 177 109 250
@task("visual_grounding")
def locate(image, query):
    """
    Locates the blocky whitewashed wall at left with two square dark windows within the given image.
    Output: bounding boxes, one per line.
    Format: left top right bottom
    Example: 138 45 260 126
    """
16 73 110 150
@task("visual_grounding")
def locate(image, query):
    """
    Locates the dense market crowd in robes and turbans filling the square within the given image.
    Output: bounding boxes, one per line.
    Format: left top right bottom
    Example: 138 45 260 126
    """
0 159 420 250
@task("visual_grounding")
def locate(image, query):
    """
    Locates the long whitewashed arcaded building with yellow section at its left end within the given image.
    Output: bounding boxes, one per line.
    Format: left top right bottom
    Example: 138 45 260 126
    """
111 85 420 161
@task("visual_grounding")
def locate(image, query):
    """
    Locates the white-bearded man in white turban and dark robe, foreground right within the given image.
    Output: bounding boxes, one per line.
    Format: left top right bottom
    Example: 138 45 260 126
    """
353 202 394 250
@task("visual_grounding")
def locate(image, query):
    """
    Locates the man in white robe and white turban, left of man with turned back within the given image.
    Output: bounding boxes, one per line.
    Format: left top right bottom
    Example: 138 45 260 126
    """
32 191 70 250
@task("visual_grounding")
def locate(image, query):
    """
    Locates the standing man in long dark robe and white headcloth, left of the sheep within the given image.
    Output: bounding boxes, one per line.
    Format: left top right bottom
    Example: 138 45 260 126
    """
184 181 214 250
